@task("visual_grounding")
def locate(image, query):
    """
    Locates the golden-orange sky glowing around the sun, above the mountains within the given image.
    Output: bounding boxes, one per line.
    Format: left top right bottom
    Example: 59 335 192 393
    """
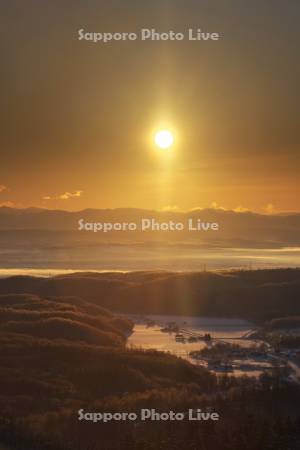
0 0 300 212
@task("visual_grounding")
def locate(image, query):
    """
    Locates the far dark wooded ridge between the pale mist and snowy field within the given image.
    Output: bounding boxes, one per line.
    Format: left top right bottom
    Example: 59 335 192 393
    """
0 269 300 321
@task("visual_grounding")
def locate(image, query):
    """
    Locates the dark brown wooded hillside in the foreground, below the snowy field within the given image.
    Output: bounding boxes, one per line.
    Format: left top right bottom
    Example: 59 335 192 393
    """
0 290 300 450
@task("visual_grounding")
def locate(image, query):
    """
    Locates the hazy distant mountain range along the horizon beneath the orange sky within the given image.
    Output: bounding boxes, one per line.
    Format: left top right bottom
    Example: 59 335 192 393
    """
0 207 300 248
